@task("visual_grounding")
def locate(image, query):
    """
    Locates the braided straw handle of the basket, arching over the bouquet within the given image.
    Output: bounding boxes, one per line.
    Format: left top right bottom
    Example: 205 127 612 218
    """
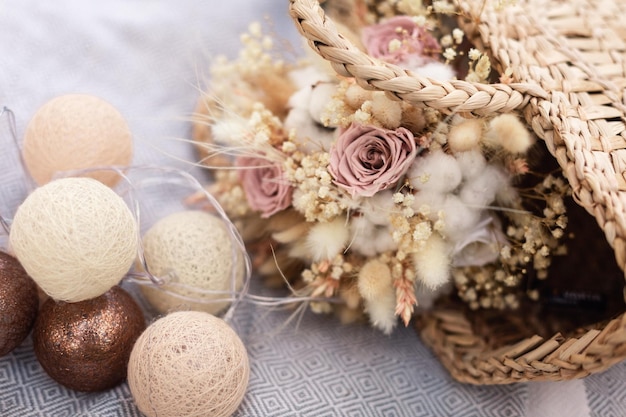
289 0 548 115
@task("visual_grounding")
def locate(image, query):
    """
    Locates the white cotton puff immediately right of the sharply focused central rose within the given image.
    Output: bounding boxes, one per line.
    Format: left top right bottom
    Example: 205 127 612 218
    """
407 152 463 193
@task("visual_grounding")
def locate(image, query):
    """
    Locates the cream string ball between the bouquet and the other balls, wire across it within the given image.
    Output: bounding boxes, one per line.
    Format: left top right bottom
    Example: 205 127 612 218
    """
141 210 244 314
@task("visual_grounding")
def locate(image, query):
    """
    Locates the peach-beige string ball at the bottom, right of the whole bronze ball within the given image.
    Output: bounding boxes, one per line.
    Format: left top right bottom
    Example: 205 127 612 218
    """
128 311 250 417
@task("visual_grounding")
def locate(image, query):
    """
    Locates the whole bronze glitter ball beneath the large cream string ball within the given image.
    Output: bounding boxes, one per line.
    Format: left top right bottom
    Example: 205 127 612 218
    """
33 287 146 392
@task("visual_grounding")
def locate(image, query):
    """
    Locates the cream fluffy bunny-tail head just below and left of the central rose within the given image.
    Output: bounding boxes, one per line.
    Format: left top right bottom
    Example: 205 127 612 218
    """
306 218 350 262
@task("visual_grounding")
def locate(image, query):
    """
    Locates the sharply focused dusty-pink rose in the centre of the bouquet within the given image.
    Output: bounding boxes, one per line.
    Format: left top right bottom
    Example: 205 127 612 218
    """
328 123 418 197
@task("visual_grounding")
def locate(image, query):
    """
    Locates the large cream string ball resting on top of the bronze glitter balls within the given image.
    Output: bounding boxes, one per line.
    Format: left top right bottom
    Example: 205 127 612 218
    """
9 178 138 302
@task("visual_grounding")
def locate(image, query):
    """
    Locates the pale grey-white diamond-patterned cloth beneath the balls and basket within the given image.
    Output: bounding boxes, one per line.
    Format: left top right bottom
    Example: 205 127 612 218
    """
0 0 626 417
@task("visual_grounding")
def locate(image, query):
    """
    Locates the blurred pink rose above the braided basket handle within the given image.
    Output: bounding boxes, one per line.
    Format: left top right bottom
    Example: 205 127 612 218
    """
361 16 441 64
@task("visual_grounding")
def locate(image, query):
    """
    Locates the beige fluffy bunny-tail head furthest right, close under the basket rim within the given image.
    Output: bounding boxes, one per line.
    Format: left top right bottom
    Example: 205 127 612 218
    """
484 113 534 154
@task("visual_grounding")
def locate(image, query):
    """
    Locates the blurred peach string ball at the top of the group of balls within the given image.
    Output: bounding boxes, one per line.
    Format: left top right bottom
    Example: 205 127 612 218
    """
22 94 133 186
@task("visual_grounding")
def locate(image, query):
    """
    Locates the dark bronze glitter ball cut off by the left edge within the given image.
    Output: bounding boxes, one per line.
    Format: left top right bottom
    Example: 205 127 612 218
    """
0 252 39 356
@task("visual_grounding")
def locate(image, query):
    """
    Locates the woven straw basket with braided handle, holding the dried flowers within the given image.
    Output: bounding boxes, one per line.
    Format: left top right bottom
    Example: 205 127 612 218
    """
290 0 626 384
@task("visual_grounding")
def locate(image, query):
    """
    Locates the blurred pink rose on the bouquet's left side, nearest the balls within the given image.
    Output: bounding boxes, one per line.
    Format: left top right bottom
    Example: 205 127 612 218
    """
236 157 293 218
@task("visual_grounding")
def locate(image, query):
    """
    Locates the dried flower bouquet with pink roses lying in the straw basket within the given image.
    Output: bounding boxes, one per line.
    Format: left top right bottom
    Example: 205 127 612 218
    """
194 0 570 333
